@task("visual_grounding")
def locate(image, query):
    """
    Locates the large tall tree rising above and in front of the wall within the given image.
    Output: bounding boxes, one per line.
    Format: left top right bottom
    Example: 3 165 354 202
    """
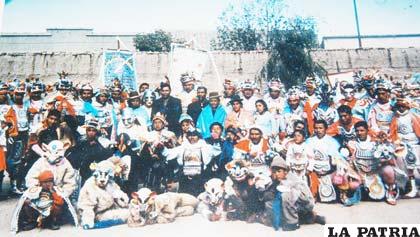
212 0 323 87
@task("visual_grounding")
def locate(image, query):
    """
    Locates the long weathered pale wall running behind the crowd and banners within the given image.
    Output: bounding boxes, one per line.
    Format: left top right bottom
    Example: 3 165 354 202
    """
0 48 420 89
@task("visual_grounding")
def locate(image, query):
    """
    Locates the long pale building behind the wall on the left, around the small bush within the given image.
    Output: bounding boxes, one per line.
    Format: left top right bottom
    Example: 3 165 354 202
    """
0 28 215 53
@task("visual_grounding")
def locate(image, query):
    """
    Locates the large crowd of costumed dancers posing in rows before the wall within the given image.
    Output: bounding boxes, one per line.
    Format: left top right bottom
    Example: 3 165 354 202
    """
0 69 420 231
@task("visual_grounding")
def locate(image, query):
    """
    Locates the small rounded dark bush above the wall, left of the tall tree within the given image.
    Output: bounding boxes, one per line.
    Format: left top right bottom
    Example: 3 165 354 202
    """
134 30 185 52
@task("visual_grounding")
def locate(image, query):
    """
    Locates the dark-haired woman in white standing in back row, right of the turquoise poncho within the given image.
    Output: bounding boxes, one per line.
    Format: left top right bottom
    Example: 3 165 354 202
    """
254 100 279 138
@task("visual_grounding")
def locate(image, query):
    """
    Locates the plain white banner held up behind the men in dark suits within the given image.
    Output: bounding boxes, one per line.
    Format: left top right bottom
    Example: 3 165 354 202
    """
169 47 209 94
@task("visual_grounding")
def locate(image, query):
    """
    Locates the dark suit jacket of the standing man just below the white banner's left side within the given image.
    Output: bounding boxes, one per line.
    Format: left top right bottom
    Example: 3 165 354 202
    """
152 96 182 136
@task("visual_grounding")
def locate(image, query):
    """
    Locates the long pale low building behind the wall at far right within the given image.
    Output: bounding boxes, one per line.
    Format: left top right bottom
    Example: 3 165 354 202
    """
321 34 420 49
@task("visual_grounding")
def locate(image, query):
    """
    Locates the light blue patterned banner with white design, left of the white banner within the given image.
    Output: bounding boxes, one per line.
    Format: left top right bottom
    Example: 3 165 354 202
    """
100 50 137 90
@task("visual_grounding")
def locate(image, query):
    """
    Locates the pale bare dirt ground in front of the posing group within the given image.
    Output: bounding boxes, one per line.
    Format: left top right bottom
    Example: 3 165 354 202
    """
0 199 420 237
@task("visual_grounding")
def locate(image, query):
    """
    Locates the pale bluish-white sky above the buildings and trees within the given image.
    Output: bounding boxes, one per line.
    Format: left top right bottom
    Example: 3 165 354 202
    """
0 0 420 36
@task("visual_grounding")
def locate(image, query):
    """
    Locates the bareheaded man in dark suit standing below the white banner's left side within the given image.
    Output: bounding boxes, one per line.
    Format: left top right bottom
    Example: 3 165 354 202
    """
152 83 182 135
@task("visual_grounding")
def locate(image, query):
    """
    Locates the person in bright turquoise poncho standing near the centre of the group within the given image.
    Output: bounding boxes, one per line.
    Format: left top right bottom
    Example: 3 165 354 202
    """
197 92 226 139
